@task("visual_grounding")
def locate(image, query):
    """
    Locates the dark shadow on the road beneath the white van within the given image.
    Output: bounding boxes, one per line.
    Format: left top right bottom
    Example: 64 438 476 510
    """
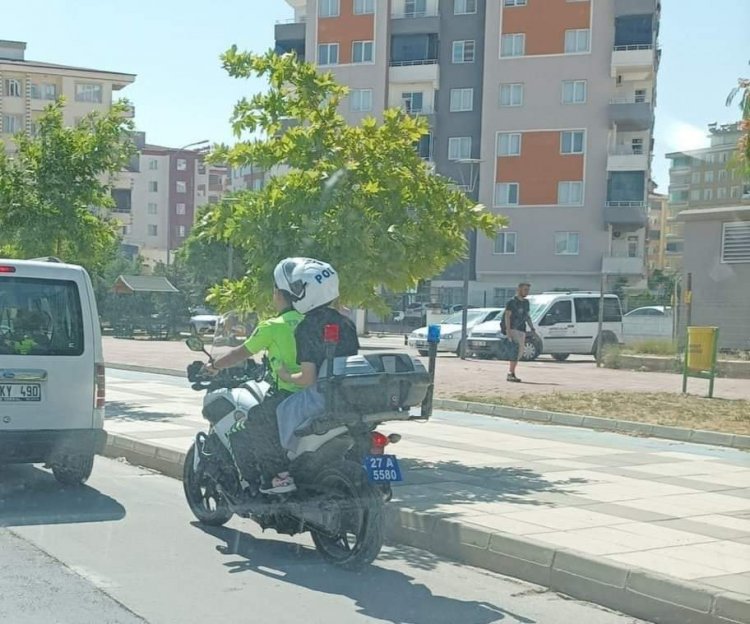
0 465 125 527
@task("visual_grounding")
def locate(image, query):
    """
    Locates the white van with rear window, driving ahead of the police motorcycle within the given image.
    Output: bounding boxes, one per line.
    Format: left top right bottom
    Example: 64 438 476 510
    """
0 258 106 485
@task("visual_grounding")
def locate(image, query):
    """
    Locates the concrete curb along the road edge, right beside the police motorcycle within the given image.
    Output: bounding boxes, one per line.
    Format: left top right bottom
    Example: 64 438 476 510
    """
103 433 750 624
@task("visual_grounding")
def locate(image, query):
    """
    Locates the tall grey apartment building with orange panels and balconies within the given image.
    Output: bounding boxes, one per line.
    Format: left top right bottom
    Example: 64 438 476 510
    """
276 0 660 305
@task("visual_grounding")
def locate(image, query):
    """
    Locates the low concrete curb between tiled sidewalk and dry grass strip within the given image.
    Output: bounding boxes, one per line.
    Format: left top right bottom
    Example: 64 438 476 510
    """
434 399 750 450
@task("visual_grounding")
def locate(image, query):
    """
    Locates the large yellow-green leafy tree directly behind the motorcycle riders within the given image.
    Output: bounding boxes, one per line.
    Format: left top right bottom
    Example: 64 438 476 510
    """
205 51 504 308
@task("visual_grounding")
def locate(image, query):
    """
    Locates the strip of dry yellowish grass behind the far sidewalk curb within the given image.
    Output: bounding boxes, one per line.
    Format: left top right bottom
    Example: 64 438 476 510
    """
456 392 750 435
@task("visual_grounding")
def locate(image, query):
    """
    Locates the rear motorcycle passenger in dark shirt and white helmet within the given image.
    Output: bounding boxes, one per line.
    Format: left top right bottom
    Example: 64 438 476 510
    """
249 258 359 494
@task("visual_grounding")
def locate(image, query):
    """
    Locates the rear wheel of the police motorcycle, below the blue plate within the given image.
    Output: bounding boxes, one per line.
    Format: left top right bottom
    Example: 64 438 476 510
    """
312 461 385 570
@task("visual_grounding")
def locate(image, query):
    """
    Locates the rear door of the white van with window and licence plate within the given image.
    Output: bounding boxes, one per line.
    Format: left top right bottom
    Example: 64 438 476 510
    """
0 263 95 431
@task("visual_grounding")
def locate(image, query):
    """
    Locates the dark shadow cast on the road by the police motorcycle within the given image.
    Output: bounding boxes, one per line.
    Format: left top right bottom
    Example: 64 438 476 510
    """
194 523 536 624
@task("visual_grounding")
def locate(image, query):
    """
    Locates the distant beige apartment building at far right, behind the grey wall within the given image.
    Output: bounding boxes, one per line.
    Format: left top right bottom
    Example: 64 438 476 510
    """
665 123 750 269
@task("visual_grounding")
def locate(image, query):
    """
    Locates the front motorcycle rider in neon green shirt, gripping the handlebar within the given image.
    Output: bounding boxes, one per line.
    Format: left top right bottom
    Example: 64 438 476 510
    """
206 281 304 491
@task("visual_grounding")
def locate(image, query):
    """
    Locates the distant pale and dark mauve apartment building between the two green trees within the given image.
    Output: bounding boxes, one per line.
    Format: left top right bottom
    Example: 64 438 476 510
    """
112 137 227 265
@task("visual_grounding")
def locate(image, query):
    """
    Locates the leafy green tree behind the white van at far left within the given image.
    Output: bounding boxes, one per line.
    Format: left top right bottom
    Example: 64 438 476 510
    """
0 99 134 271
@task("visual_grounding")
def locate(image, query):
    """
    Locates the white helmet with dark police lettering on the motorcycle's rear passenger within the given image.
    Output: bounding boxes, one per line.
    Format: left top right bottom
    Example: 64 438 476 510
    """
273 258 339 314
